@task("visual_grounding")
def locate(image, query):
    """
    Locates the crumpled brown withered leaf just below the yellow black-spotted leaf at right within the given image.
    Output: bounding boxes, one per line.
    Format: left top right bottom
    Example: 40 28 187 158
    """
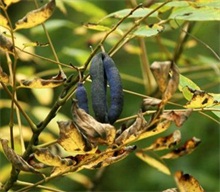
161 109 192 127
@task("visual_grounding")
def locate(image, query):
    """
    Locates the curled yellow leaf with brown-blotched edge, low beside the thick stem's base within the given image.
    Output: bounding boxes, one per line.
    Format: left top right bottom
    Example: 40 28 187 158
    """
34 148 76 167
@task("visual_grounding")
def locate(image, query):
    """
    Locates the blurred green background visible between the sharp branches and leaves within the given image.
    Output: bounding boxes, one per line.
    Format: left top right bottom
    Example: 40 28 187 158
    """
0 0 220 192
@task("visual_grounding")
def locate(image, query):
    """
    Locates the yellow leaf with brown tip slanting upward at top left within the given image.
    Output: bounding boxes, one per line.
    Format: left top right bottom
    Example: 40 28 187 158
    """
15 0 56 30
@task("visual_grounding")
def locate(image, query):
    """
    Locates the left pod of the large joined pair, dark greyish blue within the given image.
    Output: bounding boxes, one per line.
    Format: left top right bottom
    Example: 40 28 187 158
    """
90 53 108 123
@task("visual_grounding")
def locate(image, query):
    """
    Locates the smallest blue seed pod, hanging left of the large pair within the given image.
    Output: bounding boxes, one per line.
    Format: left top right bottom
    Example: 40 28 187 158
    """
76 82 89 114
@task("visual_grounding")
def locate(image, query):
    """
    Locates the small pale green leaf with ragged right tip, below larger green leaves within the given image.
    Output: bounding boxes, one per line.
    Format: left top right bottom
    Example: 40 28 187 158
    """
134 24 164 37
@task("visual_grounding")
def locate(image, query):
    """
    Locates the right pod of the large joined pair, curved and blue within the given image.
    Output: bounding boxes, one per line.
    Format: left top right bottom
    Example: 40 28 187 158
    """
102 53 124 124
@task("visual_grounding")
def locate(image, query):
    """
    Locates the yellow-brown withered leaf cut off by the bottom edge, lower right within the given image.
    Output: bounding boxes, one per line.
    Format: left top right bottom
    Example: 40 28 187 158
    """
174 171 204 192
